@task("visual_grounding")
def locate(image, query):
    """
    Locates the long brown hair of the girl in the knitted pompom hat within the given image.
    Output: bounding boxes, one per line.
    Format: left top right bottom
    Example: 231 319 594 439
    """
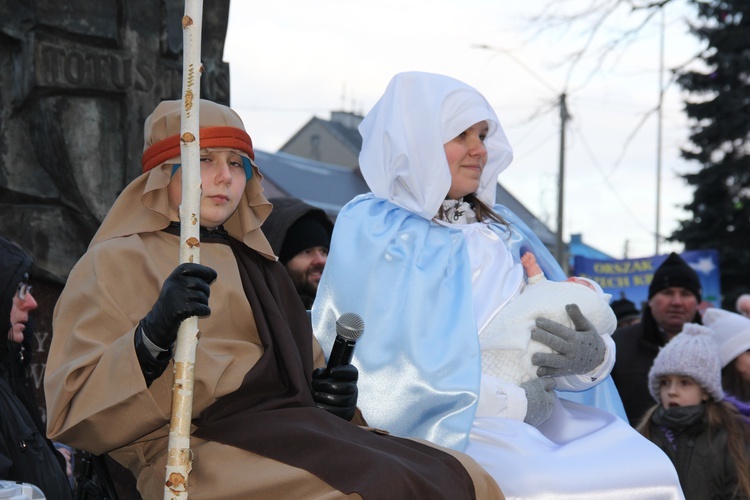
636 399 750 497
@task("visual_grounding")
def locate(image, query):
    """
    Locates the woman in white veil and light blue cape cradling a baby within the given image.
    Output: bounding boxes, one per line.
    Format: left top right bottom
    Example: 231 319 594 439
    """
312 72 682 498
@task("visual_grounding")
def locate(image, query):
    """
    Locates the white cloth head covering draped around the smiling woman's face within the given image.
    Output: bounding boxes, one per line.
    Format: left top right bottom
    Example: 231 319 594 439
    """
359 72 513 219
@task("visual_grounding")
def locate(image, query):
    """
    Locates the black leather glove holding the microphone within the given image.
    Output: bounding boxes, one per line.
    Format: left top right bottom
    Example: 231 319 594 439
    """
312 365 359 420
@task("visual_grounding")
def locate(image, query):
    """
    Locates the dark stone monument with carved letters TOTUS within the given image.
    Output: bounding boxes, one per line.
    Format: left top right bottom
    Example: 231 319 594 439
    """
0 0 235 498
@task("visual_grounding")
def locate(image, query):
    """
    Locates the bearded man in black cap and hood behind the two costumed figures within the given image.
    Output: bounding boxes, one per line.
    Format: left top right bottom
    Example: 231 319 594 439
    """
262 198 333 309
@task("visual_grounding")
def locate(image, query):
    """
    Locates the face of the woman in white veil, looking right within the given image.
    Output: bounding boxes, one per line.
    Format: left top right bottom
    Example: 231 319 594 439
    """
443 121 489 200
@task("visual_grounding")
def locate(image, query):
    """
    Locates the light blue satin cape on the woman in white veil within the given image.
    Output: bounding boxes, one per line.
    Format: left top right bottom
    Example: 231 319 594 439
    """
312 194 625 451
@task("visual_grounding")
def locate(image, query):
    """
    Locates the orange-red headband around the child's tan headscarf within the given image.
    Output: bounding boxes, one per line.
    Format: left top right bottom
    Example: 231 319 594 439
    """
141 127 255 173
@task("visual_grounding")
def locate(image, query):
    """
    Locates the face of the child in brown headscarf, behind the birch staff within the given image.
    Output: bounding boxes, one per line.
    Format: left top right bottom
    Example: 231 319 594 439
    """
167 151 247 229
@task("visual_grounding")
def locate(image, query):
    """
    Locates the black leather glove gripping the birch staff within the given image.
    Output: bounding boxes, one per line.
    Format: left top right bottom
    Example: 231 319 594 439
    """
141 263 216 350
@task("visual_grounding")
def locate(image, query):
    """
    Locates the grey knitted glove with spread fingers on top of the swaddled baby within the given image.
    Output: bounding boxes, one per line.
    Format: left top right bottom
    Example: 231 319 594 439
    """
531 304 607 377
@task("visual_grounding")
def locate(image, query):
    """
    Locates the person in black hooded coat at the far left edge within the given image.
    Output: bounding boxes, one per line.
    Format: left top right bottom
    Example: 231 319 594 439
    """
0 237 73 500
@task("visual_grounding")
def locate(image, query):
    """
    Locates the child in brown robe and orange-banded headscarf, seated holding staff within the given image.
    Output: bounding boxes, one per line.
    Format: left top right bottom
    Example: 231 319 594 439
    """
44 100 503 499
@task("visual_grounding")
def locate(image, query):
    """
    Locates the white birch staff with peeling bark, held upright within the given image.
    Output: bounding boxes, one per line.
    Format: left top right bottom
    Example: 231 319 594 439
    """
164 0 203 500
